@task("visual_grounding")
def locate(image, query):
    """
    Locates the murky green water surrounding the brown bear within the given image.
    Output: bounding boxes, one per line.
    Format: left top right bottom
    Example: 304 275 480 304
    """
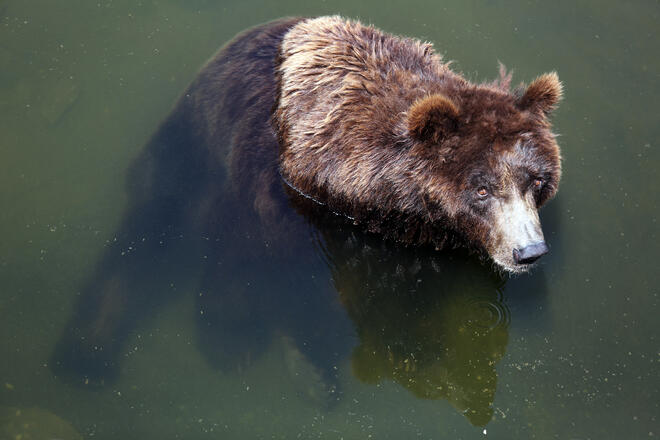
0 0 660 440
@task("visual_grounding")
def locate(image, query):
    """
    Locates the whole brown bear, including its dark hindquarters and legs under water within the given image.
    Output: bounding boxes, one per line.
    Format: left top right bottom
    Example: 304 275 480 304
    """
52 17 561 392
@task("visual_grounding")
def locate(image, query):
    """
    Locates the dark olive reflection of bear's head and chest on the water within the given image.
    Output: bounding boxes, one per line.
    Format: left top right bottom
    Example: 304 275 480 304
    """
312 210 509 426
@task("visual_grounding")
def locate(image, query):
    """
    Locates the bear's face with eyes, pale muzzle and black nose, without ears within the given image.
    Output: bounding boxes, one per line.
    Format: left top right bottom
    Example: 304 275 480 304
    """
456 140 559 272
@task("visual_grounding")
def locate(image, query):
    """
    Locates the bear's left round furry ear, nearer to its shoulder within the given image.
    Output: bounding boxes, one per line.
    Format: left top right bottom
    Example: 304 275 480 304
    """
408 94 460 142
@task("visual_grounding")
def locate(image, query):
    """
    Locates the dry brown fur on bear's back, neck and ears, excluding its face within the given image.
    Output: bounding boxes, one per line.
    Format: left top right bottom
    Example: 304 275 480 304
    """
274 17 561 258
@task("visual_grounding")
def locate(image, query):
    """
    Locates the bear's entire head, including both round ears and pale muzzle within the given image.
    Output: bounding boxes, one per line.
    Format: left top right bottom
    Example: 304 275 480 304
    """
408 74 561 272
